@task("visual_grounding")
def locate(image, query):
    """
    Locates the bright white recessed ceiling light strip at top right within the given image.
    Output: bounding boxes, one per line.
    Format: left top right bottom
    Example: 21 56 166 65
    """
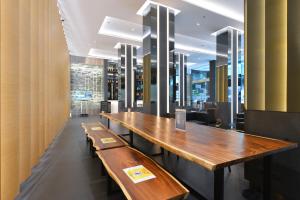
183 0 244 22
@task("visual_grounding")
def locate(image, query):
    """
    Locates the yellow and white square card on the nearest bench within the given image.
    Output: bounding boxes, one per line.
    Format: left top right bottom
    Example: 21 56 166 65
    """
123 165 155 183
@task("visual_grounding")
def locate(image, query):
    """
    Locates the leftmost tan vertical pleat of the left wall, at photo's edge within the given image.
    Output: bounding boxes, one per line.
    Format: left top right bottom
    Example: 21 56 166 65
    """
0 1 20 199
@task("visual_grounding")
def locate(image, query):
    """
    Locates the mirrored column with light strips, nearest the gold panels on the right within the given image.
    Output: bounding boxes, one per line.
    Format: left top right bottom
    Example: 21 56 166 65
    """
216 27 244 128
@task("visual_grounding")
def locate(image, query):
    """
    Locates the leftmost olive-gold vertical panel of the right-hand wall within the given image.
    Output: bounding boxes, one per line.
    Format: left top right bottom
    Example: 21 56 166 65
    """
245 0 265 110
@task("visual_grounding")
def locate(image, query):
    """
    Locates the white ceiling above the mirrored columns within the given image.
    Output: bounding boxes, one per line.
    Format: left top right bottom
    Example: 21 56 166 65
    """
58 0 244 68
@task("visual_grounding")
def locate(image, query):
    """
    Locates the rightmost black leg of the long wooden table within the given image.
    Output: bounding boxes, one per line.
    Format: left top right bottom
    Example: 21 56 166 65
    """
263 156 272 200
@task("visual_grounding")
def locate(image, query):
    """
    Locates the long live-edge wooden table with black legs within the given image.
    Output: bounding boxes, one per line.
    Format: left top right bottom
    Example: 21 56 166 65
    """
101 112 297 200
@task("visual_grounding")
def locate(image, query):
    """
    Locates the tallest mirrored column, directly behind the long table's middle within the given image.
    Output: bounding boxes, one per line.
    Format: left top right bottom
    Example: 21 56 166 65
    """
142 3 176 116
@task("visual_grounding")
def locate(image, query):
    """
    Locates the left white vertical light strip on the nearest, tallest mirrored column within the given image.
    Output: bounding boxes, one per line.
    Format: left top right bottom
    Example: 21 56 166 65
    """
156 5 160 116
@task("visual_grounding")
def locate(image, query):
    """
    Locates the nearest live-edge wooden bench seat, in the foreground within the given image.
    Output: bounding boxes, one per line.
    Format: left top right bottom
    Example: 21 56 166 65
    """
96 146 189 200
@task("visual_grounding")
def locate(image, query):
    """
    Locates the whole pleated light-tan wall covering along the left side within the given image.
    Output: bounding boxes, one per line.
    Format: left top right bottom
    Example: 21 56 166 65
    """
0 0 70 200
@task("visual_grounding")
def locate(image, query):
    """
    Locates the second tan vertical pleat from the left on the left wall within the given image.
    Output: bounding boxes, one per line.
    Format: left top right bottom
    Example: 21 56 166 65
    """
18 0 31 181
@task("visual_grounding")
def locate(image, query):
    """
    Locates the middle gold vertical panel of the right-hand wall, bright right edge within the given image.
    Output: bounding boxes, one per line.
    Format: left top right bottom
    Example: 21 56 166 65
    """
266 0 287 111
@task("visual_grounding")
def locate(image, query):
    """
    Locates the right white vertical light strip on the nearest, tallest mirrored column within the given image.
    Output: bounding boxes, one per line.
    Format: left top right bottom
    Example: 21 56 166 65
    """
167 8 170 113
